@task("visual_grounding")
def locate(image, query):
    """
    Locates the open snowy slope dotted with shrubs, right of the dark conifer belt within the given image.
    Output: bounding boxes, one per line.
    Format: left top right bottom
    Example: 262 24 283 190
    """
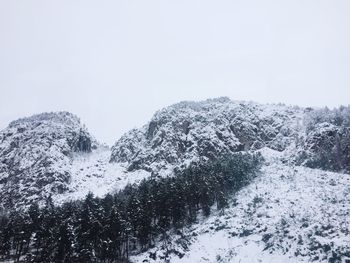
132 149 350 263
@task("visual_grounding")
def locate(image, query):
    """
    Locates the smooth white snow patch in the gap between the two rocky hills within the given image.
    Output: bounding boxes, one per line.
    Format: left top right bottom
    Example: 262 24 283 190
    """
54 148 150 204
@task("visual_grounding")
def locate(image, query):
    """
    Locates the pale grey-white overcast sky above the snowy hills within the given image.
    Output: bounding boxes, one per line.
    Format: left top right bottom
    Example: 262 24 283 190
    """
0 0 350 144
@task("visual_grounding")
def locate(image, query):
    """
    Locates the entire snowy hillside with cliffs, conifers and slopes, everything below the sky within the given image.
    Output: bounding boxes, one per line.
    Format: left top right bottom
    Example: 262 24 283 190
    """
0 98 350 263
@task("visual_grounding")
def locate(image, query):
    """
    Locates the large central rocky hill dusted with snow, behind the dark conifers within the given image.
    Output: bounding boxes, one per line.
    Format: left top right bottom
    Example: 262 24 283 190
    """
111 98 304 172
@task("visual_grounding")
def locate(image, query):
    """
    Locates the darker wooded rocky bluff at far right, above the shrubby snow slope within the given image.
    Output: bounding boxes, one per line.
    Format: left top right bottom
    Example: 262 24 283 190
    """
295 106 350 173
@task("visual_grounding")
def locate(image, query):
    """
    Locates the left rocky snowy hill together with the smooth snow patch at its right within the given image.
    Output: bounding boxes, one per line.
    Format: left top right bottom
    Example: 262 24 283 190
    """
0 112 148 208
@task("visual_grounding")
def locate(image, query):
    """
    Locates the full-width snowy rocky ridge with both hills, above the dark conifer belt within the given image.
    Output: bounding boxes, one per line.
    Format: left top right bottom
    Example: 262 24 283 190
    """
0 97 350 207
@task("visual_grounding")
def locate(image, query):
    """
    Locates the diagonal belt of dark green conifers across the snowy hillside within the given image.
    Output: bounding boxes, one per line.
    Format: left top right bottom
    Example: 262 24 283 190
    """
0 153 261 263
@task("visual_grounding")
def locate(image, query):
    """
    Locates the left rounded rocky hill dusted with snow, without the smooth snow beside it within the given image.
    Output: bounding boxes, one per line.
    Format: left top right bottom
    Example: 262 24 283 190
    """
0 112 94 210
